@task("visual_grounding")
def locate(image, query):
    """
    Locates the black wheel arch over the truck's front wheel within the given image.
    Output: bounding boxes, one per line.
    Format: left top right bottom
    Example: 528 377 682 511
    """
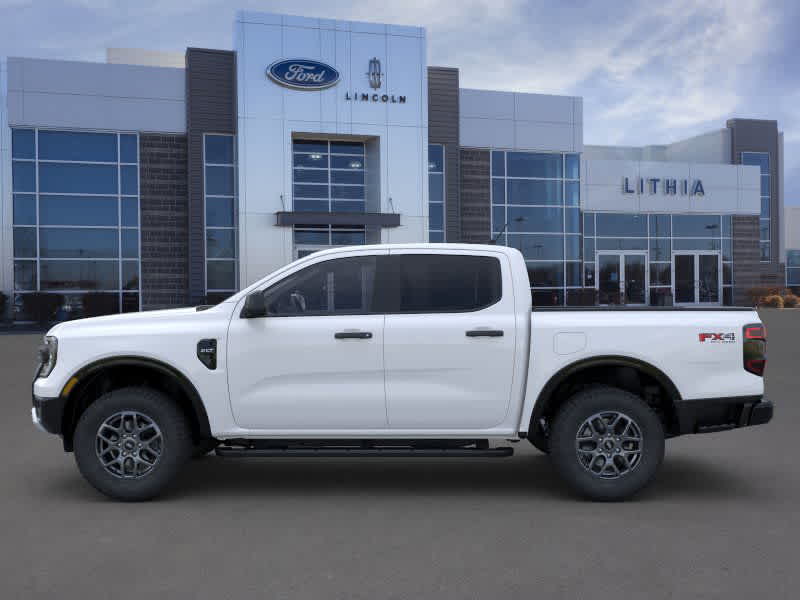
61 355 212 451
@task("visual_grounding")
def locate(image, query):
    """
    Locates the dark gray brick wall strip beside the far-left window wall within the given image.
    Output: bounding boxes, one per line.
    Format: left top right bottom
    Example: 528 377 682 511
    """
139 133 189 310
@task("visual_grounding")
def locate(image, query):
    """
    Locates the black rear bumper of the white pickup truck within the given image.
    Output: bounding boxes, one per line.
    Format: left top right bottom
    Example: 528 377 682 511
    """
676 396 774 434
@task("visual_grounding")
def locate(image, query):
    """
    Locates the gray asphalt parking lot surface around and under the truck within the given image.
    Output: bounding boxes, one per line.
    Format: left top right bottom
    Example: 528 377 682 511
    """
0 310 800 600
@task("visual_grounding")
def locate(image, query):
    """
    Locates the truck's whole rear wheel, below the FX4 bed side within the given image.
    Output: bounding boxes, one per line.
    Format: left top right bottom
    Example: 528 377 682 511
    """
549 386 664 501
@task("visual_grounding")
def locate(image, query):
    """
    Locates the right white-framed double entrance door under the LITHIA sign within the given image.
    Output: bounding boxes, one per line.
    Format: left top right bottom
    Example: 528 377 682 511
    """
672 252 722 305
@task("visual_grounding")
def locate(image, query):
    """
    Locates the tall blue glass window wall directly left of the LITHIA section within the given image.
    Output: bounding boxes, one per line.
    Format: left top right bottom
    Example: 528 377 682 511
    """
491 150 582 306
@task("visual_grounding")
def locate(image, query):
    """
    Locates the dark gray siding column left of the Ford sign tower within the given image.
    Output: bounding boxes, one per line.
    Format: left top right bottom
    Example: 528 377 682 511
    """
186 48 236 303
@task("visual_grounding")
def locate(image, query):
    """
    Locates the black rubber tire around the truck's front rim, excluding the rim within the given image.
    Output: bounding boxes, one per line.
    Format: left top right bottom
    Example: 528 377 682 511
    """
74 387 193 502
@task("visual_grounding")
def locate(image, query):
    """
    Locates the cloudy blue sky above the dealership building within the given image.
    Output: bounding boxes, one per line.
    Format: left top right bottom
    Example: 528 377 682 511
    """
0 0 800 205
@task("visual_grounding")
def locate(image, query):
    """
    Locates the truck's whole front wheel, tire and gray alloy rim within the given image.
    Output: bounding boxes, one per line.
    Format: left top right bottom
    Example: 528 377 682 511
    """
74 387 192 501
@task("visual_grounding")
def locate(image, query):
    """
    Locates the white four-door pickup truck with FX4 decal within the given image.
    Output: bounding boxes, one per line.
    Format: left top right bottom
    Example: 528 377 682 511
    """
28 244 773 500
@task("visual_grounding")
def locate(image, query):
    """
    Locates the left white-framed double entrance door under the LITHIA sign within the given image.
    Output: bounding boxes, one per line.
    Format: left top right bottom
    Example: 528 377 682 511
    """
596 252 647 306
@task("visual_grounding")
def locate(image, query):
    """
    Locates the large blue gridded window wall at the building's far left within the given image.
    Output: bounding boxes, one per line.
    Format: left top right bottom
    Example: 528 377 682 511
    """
12 129 140 320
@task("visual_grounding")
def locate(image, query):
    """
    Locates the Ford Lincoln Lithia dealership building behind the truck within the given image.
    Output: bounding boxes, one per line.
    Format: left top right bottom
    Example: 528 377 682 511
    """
0 12 788 320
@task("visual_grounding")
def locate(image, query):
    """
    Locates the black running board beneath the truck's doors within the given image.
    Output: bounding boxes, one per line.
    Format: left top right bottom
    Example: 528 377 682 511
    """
216 446 514 458
